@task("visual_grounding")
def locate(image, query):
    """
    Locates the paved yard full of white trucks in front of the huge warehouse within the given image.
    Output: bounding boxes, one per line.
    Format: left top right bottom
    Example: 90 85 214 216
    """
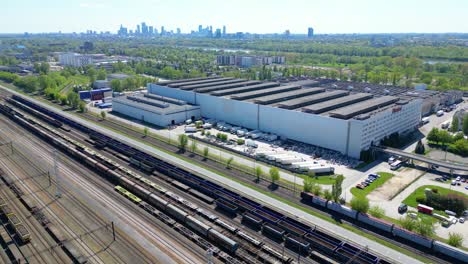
177 121 360 174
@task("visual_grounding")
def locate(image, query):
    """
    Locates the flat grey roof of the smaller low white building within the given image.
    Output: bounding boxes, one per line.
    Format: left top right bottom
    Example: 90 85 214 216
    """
113 95 200 115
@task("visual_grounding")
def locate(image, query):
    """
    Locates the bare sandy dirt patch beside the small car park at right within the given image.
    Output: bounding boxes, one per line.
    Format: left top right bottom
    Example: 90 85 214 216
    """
367 168 421 202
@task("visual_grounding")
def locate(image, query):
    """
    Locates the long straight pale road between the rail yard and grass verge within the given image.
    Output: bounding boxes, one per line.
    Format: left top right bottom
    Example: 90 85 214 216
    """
4 87 421 263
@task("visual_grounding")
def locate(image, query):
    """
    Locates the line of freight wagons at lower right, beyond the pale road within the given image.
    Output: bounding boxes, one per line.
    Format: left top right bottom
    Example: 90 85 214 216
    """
301 192 468 263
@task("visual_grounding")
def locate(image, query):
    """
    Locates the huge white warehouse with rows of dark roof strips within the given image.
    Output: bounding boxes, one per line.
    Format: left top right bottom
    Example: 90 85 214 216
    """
139 78 422 158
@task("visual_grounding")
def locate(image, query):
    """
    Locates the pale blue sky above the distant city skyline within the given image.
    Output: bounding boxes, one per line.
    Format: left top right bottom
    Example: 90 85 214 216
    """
0 0 468 33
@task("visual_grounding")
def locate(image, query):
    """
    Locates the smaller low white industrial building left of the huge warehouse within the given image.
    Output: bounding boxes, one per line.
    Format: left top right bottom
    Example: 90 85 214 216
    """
112 94 200 127
